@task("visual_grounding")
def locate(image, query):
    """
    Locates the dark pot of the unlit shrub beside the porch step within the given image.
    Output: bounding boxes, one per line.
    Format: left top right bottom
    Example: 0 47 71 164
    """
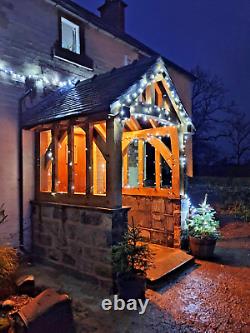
116 273 146 301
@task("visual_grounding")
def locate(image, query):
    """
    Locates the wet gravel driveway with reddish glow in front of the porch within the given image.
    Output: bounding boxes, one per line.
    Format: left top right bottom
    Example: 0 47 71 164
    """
18 219 250 333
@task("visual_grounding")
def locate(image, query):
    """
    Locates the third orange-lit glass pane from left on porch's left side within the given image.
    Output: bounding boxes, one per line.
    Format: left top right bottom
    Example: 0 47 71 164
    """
74 126 86 193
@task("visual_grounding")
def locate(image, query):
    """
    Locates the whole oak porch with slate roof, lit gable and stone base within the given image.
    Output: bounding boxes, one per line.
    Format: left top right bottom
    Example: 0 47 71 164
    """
23 58 192 286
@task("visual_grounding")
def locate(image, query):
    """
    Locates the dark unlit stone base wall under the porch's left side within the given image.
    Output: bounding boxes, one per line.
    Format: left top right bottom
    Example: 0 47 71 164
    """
31 202 128 290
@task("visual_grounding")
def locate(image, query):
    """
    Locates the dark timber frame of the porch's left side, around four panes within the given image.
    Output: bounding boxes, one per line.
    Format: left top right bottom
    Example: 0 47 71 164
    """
35 117 122 208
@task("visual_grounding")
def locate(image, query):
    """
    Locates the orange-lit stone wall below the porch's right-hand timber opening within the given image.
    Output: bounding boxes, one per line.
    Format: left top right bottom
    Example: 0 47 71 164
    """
123 195 181 247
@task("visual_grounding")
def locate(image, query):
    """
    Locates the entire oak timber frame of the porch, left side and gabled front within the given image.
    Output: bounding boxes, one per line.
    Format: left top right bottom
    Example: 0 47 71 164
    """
33 75 189 208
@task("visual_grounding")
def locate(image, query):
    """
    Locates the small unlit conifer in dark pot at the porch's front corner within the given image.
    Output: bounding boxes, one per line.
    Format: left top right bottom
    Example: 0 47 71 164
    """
112 223 152 301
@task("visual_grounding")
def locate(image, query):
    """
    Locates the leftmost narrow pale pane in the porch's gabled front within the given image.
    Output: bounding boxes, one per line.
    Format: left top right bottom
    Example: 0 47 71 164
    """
128 140 139 187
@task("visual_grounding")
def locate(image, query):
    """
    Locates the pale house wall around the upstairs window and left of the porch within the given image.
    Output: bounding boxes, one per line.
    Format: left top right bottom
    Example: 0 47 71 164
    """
0 0 137 245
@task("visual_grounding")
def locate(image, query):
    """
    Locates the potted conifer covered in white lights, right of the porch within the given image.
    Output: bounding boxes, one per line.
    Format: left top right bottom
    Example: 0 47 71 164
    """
187 194 220 258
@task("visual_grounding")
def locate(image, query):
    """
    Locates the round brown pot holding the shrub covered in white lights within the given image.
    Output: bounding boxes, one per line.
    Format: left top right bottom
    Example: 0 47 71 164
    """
189 236 216 259
